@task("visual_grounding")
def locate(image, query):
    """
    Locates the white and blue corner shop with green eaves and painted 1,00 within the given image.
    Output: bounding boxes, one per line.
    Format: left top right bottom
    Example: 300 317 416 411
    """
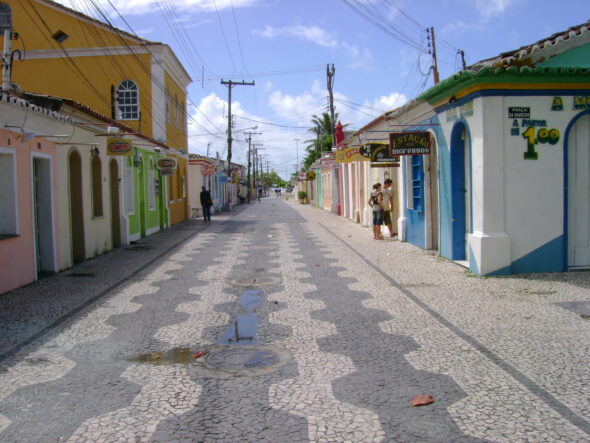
394 23 590 275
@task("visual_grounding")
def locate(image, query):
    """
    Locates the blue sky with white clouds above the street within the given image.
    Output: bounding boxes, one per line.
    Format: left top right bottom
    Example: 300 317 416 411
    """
58 0 590 179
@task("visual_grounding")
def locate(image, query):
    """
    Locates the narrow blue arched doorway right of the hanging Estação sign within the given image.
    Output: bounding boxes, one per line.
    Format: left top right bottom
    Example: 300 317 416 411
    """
451 122 471 260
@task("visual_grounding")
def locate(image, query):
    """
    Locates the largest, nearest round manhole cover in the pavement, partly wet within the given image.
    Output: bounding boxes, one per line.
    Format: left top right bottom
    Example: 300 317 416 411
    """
191 345 290 378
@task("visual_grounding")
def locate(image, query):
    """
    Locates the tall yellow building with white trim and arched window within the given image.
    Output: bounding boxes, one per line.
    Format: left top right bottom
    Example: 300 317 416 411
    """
0 0 191 227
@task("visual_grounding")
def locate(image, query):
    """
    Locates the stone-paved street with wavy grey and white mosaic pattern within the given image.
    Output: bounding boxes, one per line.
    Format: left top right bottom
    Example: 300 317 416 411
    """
0 196 590 442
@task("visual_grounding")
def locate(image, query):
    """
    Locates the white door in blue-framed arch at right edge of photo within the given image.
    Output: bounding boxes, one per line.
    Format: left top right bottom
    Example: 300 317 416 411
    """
567 115 590 268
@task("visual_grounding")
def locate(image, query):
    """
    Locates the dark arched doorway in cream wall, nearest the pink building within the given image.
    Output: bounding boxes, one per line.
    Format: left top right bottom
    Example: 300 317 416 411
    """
69 151 86 263
